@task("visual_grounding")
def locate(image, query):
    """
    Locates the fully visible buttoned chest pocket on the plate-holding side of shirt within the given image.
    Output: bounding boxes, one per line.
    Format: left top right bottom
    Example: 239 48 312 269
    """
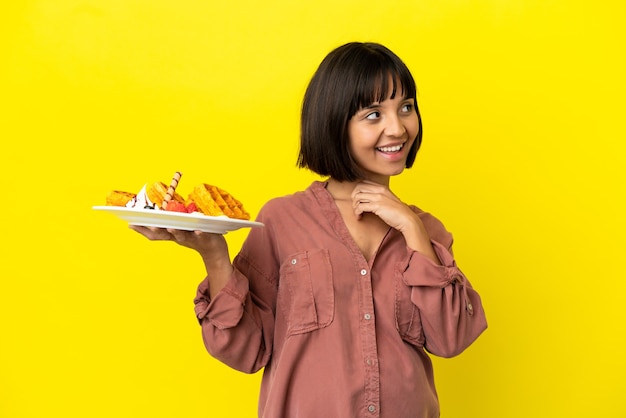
277 249 335 336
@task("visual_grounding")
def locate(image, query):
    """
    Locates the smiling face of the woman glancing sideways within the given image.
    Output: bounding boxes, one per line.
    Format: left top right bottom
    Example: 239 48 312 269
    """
348 89 419 183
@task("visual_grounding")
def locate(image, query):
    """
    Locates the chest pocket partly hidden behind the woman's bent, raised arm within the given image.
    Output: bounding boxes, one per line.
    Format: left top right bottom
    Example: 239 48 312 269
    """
394 268 424 348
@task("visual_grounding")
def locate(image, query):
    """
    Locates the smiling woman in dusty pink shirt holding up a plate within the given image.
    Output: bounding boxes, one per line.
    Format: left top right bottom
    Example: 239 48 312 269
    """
133 43 486 418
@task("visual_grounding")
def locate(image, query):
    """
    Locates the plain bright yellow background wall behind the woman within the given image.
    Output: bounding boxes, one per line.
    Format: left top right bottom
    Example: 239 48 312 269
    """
0 0 626 418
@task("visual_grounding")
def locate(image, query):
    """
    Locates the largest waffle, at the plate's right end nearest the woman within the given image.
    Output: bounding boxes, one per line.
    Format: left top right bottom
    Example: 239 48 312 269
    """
188 184 250 220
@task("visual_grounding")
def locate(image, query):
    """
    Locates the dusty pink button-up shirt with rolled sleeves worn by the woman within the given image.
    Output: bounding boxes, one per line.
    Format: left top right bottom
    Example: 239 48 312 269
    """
195 182 487 418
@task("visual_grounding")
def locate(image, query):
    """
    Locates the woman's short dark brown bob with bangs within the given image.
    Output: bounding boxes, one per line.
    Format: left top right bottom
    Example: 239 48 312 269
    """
298 42 422 181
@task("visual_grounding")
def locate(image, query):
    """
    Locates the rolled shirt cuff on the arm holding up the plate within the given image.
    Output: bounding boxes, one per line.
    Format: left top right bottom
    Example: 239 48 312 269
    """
194 271 249 329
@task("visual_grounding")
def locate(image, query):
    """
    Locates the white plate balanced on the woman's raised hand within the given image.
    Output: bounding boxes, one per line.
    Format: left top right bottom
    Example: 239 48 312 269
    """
93 206 263 234
